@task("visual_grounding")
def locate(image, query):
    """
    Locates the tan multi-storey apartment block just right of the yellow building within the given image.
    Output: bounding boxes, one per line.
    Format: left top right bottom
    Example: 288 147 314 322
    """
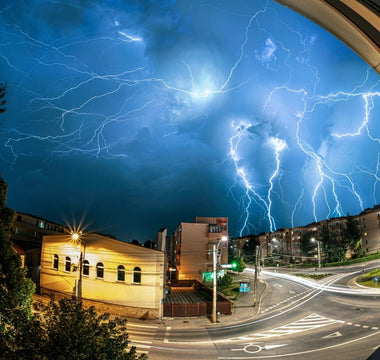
169 217 228 281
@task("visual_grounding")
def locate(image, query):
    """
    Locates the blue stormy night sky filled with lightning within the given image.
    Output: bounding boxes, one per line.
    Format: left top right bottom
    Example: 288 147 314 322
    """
0 0 380 242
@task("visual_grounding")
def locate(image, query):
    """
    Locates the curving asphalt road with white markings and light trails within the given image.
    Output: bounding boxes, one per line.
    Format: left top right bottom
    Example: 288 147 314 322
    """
130 262 380 360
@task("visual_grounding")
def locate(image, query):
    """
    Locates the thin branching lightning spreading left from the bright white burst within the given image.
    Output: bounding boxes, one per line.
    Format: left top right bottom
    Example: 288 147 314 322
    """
0 1 268 164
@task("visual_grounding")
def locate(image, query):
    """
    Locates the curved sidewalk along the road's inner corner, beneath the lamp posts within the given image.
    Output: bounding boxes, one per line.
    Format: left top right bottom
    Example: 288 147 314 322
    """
151 274 267 328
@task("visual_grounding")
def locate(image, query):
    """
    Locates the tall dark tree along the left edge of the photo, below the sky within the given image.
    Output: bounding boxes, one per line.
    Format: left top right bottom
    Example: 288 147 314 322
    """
0 175 35 358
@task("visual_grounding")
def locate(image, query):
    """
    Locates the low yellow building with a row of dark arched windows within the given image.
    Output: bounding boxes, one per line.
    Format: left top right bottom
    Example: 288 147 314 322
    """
40 234 165 318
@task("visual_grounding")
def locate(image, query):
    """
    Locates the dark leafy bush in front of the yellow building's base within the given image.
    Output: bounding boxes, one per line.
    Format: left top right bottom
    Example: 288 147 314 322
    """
36 298 147 360
